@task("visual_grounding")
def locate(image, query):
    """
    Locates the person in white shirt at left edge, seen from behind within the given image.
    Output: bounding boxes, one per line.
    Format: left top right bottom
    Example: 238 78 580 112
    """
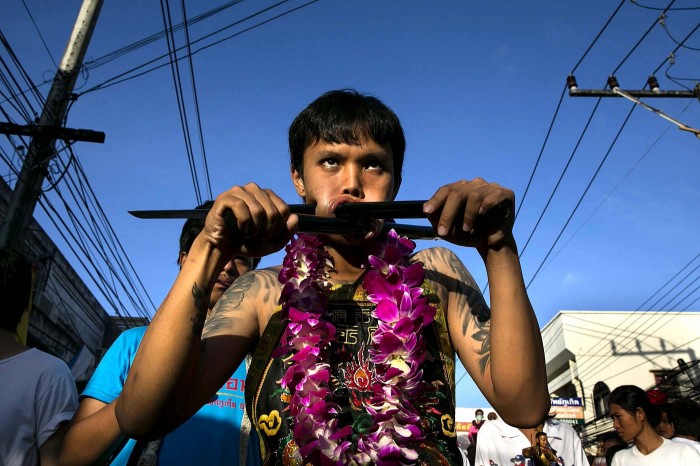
0 249 78 466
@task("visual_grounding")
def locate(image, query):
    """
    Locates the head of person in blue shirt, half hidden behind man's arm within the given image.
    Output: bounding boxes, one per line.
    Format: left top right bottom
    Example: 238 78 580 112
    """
177 201 260 309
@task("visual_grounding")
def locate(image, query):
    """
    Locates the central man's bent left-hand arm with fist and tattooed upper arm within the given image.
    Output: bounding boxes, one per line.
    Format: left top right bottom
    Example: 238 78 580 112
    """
115 184 298 439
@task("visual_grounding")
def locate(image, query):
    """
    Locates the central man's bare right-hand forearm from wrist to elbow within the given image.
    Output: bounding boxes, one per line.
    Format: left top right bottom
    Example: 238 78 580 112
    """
482 241 549 427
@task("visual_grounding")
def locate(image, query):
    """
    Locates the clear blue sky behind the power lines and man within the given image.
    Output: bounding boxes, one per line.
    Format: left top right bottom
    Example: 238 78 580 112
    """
0 0 700 406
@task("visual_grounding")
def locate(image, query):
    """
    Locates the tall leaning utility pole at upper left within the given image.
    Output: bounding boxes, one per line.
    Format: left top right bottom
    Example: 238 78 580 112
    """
0 0 103 249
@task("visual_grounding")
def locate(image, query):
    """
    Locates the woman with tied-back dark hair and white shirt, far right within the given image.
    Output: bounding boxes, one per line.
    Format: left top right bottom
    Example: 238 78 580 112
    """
610 385 700 466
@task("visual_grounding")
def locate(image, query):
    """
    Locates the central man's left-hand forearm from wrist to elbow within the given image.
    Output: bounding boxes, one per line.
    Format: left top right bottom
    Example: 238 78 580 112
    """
115 237 226 438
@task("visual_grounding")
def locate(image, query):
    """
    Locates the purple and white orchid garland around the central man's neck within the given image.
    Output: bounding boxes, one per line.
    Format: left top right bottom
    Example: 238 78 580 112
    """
273 231 436 465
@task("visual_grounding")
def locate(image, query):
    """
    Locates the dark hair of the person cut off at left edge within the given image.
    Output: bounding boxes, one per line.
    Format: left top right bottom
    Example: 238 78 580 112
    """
0 249 32 332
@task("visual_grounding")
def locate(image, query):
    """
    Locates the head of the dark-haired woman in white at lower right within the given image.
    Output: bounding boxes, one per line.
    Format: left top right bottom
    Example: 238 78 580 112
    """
610 385 661 443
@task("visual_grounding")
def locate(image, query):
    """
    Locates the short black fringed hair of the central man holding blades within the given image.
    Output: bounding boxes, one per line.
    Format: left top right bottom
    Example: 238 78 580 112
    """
289 89 406 186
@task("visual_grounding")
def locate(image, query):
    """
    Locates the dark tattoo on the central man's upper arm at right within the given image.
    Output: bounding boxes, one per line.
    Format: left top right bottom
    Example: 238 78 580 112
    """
424 248 491 374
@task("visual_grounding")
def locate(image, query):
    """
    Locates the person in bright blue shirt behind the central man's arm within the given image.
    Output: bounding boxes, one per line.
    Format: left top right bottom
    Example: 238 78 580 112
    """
60 201 260 466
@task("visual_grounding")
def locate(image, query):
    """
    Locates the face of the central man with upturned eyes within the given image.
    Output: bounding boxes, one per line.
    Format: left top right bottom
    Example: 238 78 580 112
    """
292 139 398 228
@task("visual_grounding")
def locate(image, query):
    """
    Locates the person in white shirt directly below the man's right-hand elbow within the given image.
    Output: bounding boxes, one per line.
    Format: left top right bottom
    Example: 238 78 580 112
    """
474 418 588 466
